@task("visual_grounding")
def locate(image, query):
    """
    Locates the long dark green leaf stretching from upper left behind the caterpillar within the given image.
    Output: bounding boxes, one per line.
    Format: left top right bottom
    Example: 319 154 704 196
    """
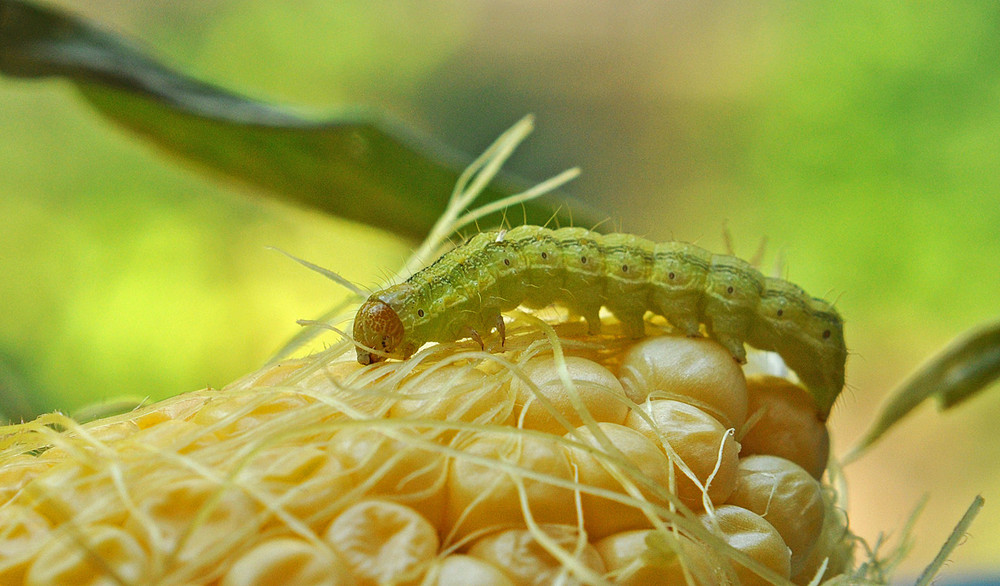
0 0 607 239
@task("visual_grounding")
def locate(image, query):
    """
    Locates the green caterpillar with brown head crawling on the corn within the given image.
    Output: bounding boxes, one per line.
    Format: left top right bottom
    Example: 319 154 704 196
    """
354 226 847 420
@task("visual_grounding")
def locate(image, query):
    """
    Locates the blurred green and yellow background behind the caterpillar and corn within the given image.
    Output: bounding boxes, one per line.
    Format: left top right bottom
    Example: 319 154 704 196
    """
0 0 1000 583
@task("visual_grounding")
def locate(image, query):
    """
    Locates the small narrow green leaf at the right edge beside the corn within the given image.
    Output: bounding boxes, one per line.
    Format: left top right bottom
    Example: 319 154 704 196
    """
845 321 1000 462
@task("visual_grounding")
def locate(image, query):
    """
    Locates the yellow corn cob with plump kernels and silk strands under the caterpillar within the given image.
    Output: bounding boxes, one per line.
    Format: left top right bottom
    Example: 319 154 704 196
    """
0 317 853 586
